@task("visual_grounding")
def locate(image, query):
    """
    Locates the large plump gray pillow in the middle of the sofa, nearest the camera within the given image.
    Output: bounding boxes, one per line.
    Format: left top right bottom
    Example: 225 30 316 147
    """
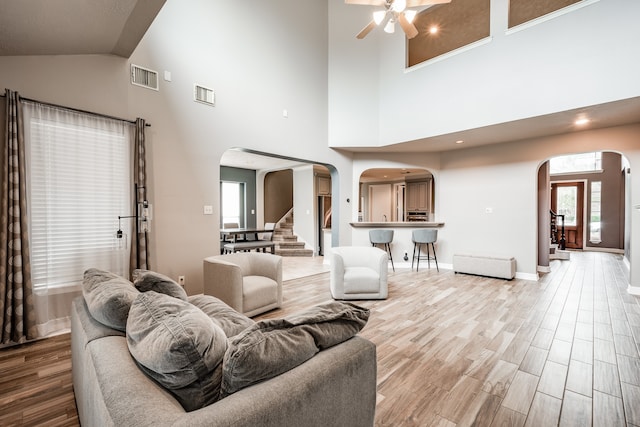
127 291 227 411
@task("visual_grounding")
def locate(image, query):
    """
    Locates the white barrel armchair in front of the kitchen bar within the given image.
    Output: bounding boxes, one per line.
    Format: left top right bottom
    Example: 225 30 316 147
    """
330 246 389 300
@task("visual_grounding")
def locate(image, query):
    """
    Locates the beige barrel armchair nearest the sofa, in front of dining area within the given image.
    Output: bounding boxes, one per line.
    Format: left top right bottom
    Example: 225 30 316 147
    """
204 252 282 317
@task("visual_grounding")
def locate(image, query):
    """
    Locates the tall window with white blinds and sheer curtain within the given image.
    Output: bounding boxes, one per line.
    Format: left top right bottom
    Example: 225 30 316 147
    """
25 103 133 291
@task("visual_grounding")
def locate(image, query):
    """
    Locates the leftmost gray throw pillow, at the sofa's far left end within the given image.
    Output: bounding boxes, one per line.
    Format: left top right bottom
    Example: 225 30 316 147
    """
82 268 140 331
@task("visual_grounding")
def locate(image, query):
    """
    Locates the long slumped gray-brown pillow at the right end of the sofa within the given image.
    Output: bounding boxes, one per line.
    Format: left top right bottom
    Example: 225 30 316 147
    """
221 301 369 397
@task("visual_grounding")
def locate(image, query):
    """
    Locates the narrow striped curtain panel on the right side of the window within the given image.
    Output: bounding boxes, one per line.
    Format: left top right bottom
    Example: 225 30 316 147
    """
130 118 151 277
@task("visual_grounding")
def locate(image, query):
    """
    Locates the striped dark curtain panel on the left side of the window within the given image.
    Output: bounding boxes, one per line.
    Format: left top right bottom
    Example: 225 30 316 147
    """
0 89 37 344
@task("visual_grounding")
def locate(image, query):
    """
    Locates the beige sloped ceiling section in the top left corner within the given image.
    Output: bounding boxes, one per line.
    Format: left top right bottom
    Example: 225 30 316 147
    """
0 0 166 58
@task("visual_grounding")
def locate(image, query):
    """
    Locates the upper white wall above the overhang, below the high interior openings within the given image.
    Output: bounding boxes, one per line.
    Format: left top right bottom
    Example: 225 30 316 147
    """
329 0 640 147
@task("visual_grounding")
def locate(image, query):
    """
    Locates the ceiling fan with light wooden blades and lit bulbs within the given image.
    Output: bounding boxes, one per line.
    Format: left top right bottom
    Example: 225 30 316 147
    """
345 0 451 39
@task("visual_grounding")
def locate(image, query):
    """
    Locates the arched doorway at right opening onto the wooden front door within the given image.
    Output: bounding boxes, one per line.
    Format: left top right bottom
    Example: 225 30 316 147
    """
538 151 629 272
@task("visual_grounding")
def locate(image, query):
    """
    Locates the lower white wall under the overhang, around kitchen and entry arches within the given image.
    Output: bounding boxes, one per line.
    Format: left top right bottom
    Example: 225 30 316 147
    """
352 124 640 287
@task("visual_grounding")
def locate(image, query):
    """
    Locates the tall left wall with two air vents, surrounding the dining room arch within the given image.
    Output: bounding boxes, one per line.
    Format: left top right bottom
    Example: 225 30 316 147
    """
0 0 360 293
